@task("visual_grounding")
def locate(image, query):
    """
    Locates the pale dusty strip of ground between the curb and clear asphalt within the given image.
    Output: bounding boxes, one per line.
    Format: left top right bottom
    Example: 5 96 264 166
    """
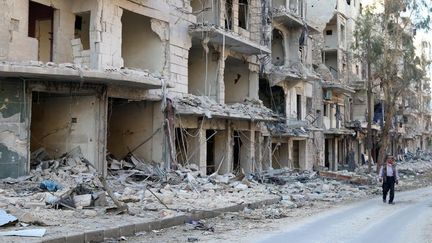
117 171 432 243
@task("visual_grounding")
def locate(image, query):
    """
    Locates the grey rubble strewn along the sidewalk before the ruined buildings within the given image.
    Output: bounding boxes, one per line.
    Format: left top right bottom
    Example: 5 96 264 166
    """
0 145 432 240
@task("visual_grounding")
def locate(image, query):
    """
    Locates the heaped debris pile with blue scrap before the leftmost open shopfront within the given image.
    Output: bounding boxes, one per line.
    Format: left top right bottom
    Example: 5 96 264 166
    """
0 147 115 213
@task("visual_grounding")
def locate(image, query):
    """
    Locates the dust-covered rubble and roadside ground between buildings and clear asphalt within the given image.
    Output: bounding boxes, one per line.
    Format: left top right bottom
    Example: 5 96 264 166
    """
0 151 432 242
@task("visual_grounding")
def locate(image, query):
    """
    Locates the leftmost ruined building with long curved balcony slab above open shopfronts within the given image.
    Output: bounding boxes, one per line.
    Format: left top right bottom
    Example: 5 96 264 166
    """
0 0 190 178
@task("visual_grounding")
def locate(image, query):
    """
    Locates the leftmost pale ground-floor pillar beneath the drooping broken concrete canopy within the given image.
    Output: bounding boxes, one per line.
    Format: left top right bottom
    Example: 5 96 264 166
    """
187 128 207 175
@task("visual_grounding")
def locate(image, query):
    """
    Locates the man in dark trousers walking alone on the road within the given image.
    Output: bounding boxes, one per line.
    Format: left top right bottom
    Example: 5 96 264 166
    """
379 155 399 204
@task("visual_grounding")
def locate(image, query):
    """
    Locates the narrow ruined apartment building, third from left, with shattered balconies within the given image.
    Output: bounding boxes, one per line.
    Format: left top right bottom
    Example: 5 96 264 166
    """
260 0 324 170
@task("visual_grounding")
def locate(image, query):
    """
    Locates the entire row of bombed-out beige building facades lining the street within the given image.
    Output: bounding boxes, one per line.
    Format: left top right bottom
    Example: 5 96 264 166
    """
0 0 431 178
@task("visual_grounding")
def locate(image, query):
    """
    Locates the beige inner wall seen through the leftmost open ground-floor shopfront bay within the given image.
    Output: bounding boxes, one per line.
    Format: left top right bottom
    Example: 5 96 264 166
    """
31 92 100 164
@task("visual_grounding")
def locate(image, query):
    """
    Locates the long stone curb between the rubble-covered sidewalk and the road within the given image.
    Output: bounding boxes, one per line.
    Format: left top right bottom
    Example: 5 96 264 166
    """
41 197 281 243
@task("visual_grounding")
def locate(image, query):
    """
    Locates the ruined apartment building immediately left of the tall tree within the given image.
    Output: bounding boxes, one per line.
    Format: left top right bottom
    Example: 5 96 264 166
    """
307 0 366 170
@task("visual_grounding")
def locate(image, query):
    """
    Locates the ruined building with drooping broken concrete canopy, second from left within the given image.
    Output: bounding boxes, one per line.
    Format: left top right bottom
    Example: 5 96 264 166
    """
173 0 276 174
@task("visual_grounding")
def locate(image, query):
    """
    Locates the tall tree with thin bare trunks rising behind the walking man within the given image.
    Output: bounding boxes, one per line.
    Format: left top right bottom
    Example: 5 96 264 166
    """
355 0 432 173
